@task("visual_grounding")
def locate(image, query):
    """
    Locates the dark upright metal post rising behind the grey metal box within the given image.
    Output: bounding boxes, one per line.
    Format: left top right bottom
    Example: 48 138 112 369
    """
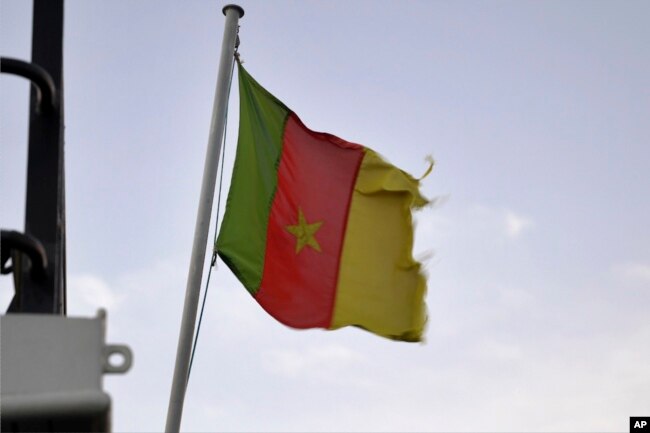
15 0 66 315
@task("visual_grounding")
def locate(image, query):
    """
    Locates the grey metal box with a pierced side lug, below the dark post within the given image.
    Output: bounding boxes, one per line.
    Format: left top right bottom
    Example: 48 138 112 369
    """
0 310 133 431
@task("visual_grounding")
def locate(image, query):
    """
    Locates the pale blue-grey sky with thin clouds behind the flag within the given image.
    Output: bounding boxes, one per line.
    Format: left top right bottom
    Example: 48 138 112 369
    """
0 0 650 431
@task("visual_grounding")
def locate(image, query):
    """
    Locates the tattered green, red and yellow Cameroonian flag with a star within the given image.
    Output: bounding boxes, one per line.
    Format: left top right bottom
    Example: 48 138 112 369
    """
217 63 427 341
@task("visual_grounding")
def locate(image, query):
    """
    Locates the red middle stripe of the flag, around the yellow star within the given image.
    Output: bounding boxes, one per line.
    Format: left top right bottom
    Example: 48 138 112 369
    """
255 113 363 328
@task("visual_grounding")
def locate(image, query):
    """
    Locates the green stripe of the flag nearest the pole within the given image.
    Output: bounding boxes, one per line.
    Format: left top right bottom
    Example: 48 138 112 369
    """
217 63 289 294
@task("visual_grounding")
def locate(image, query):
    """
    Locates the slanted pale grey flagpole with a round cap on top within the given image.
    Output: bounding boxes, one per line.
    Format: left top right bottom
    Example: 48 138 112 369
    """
165 4 244 433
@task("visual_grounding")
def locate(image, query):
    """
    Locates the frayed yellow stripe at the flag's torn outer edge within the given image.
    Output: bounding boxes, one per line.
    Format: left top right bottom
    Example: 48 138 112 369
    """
330 149 427 341
